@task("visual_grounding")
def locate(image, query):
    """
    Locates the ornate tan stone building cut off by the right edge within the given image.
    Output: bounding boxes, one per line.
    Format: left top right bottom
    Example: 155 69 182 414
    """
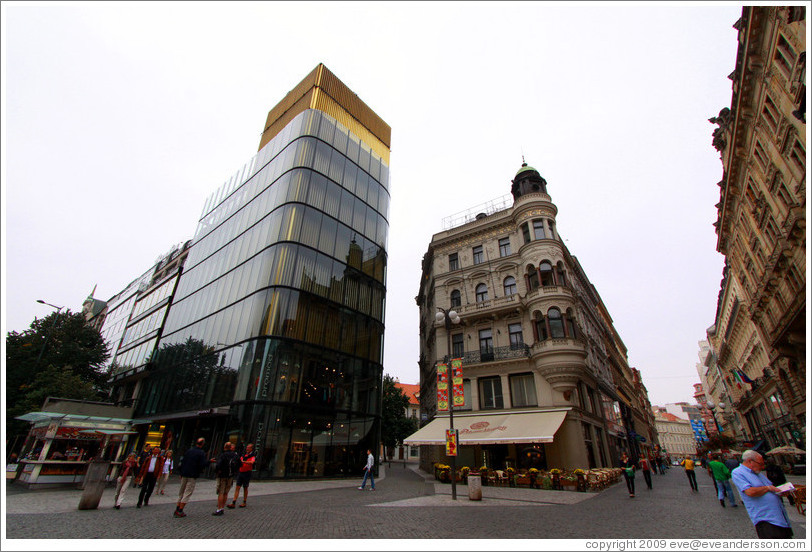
708 6 806 446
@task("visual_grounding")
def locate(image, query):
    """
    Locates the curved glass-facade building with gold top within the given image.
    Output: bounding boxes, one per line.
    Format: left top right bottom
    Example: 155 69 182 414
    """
134 65 390 478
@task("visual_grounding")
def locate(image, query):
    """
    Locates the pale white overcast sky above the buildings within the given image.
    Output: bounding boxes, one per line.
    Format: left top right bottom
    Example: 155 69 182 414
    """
1 2 741 404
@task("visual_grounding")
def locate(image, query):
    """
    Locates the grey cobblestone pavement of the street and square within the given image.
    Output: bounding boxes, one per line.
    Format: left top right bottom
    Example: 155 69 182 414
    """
5 464 806 547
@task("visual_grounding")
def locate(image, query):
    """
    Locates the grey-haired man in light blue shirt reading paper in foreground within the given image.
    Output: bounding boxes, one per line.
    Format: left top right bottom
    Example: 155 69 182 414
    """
731 450 793 539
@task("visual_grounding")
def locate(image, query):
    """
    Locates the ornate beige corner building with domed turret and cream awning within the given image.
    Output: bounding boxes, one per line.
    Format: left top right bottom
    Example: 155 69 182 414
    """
406 164 656 469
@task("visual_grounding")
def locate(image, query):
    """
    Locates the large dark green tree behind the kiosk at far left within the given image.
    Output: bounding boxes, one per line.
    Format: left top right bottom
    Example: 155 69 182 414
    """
6 310 110 444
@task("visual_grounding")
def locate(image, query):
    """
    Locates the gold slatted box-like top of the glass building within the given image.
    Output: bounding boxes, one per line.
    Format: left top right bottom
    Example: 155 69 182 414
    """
259 63 392 164
